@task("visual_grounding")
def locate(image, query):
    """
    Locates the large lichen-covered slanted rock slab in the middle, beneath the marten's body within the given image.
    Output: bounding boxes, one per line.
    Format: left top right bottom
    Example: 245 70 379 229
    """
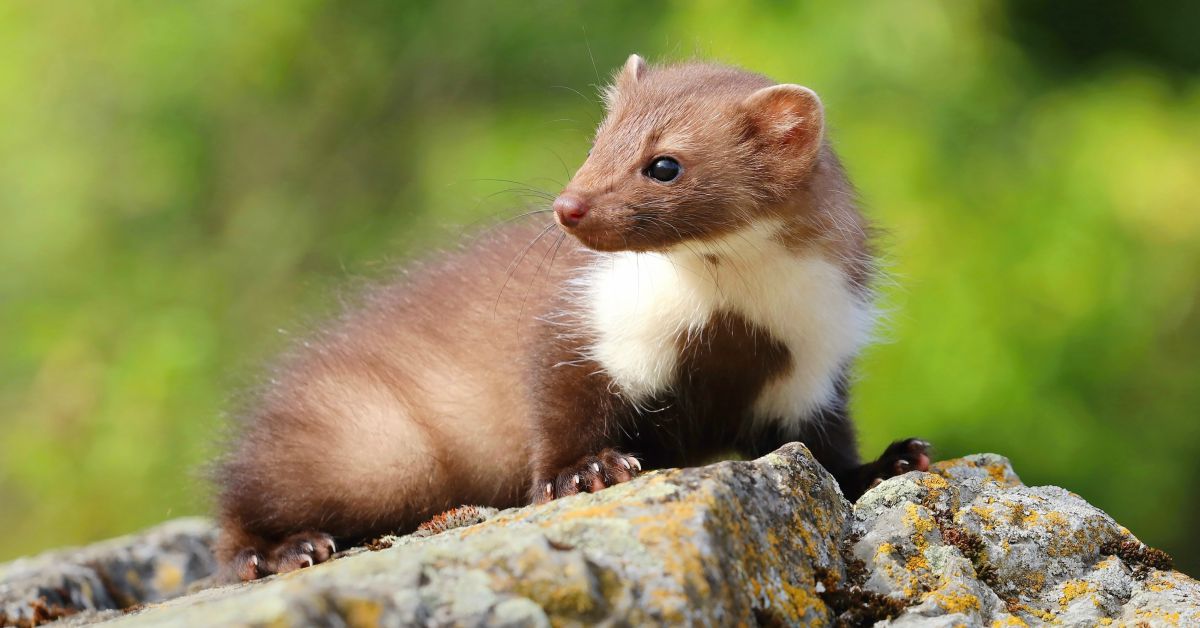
93 444 848 626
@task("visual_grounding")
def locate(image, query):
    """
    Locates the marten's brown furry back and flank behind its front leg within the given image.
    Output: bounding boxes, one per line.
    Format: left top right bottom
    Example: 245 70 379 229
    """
217 223 578 558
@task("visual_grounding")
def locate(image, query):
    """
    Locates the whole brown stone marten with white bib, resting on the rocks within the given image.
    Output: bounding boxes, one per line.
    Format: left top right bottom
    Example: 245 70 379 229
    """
216 55 929 580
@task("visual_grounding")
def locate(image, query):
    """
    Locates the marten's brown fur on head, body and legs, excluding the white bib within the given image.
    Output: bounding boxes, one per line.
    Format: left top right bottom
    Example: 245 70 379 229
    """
217 58 916 576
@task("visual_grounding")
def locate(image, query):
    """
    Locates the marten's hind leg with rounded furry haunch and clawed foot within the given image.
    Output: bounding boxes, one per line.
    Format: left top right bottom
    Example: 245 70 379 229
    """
214 360 465 579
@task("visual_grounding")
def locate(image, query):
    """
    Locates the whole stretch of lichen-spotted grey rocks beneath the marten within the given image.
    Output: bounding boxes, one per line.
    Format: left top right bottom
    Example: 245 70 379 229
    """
0 444 1200 626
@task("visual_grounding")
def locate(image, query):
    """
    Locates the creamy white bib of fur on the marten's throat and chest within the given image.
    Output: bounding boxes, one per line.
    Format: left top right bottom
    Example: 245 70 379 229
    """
581 223 872 432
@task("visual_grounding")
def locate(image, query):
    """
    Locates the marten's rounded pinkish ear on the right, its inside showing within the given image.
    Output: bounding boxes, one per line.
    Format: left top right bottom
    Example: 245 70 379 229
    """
742 84 824 166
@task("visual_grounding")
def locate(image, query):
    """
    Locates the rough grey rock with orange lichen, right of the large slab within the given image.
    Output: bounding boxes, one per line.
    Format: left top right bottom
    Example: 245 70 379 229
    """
847 454 1200 626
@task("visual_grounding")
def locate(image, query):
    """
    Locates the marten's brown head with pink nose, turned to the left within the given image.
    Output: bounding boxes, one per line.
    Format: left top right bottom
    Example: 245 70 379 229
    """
554 54 823 251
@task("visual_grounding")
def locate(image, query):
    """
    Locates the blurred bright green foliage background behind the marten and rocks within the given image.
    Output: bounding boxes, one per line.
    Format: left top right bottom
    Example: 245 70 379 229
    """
0 0 1200 574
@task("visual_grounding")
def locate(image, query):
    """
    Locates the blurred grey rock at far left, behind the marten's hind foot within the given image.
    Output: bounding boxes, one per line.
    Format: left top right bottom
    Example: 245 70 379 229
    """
0 519 216 626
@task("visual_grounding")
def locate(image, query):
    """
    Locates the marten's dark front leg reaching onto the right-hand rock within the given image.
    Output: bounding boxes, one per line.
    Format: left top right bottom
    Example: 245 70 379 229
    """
740 385 930 502
